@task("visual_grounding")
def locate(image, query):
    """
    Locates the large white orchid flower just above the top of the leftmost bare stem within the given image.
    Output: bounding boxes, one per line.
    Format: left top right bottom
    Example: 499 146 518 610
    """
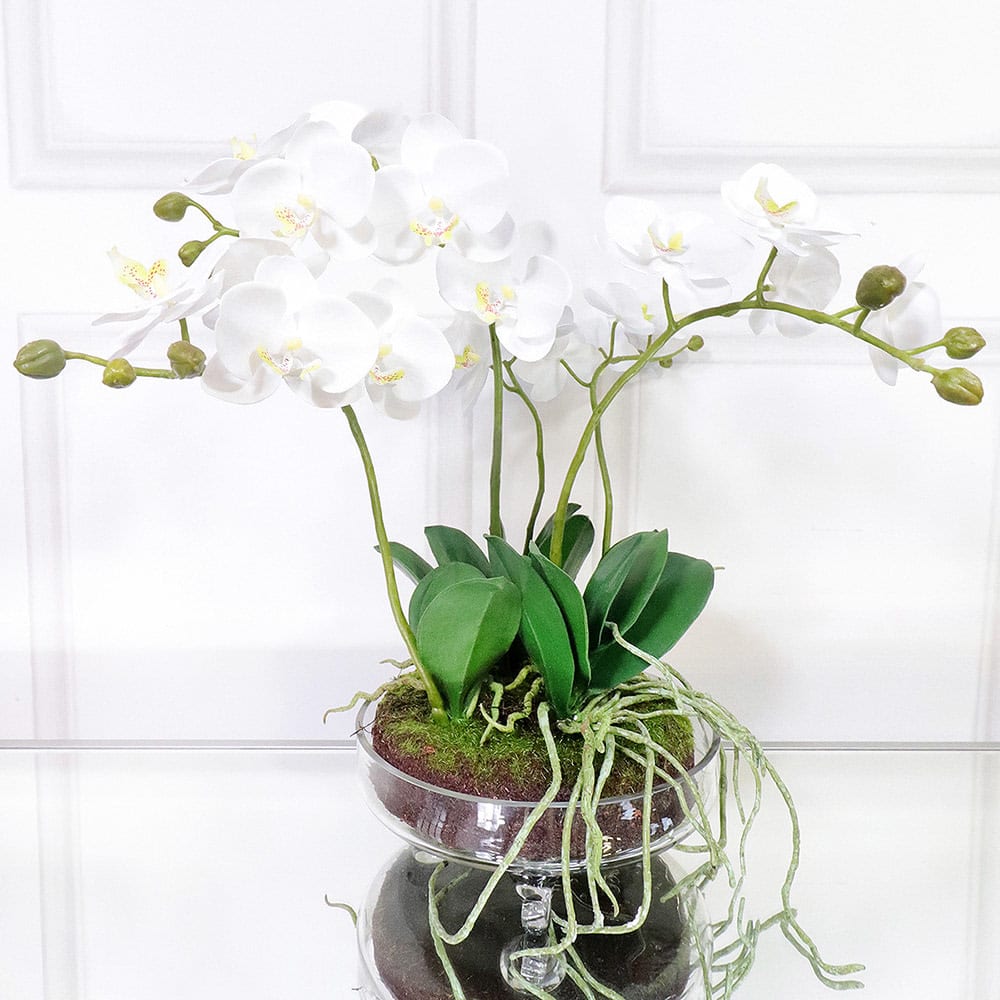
202 257 379 407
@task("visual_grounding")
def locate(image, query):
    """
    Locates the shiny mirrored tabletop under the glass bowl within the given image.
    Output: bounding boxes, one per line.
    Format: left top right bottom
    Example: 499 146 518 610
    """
0 742 1000 1000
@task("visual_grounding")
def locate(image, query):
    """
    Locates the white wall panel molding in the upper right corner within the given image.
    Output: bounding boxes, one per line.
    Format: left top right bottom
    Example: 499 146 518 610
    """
602 0 1000 193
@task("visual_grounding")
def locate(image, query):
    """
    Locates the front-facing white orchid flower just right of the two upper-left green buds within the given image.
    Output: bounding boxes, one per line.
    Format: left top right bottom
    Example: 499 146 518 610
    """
233 121 375 260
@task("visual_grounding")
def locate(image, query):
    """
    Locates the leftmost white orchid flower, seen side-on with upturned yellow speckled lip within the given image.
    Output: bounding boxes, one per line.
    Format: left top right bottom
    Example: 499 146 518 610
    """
93 247 222 358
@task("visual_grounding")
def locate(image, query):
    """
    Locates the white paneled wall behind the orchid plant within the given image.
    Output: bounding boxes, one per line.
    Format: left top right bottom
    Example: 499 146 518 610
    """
0 0 1000 743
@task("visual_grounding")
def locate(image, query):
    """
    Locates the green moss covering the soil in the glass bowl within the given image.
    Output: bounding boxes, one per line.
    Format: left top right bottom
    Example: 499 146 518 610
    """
373 682 694 799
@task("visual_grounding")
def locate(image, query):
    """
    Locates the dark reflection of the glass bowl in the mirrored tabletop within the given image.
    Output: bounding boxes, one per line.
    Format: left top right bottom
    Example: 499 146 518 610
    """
358 849 712 1000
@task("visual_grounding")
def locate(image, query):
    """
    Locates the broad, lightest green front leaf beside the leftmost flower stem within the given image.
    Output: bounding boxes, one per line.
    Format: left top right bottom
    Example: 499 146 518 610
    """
416 578 521 718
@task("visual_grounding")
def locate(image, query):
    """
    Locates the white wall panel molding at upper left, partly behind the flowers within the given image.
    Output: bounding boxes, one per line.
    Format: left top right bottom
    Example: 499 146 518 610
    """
3 0 476 188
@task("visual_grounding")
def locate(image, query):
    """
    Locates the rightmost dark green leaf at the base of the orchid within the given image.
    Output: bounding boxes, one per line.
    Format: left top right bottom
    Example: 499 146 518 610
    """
590 552 715 691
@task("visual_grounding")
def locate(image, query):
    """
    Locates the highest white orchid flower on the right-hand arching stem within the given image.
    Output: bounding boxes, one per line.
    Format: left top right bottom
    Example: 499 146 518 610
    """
722 163 857 257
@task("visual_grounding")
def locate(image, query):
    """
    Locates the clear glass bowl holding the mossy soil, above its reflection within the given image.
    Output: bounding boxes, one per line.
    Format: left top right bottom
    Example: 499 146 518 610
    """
357 702 720 871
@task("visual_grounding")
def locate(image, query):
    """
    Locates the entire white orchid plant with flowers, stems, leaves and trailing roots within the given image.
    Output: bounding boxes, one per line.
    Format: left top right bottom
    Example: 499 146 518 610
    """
14 104 984 998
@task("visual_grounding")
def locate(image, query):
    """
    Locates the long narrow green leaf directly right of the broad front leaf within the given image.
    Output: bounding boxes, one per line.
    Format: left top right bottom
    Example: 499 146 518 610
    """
486 535 578 718
